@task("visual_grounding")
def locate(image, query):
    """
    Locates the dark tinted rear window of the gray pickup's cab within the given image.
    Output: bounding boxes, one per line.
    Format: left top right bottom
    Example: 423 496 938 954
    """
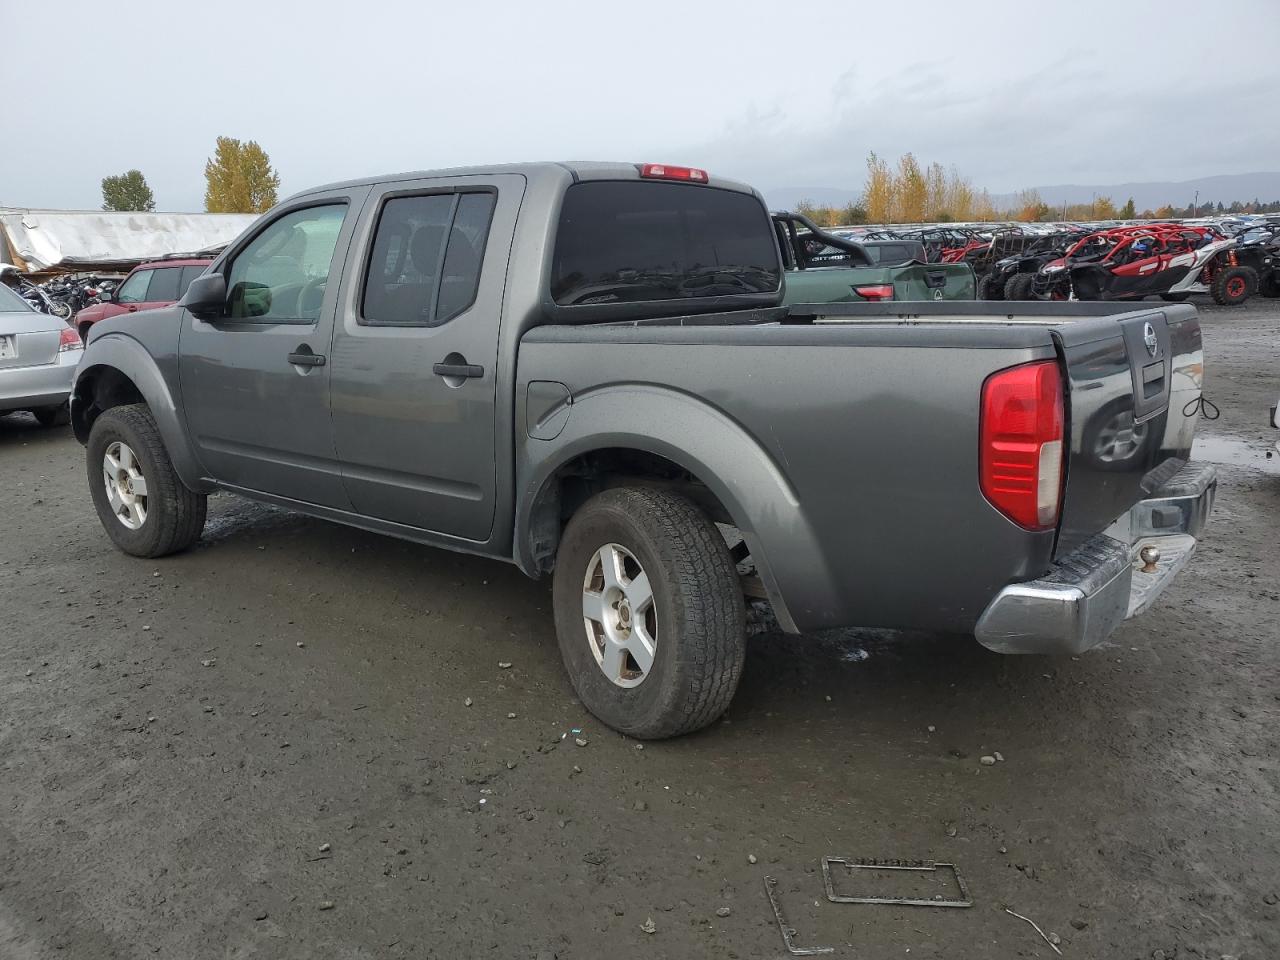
552 180 782 306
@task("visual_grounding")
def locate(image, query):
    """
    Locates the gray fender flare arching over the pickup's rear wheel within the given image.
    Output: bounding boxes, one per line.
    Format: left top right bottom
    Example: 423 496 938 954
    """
513 384 837 632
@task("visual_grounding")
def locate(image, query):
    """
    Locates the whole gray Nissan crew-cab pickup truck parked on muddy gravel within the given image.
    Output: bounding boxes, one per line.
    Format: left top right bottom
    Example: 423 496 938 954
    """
72 164 1215 737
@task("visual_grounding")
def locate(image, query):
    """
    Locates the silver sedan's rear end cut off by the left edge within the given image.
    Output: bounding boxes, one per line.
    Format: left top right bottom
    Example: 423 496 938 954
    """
0 284 84 426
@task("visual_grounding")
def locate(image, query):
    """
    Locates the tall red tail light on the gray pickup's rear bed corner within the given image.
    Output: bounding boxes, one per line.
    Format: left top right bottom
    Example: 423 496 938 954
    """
979 360 1064 530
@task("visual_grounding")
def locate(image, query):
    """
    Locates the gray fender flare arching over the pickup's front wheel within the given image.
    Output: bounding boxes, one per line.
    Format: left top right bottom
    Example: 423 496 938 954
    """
70 332 214 493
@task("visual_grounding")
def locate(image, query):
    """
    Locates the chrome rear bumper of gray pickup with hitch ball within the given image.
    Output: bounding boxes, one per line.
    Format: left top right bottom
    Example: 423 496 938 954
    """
974 463 1217 654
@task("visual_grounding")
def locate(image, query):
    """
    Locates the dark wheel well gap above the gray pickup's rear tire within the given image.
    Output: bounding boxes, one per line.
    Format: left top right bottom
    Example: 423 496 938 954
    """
527 448 736 573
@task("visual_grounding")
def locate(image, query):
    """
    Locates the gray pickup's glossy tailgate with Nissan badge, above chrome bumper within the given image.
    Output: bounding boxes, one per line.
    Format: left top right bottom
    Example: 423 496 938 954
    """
1053 305 1203 556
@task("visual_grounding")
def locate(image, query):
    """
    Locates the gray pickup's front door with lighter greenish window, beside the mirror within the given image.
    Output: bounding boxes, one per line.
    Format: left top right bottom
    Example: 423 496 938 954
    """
179 187 369 508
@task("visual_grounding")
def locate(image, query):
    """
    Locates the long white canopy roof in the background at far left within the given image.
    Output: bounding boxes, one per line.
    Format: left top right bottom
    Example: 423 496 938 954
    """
0 207 259 273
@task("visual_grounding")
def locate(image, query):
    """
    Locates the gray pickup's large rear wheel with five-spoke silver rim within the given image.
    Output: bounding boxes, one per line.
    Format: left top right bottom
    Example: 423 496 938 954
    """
553 486 746 740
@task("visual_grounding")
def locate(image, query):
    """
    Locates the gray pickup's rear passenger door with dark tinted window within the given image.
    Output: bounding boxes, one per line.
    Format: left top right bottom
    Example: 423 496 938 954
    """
330 175 525 541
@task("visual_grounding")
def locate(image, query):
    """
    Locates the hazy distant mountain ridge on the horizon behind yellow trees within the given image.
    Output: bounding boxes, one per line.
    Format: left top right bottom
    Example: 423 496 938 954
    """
764 173 1280 217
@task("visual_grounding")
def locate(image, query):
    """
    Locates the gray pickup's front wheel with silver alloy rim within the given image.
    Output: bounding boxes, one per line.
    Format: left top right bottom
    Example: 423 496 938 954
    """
86 403 207 557
